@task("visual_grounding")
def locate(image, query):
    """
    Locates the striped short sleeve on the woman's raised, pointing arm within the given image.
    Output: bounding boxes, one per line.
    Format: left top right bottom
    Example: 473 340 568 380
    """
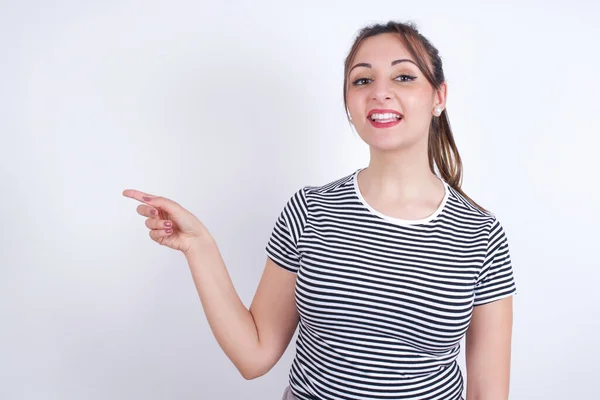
265 188 308 273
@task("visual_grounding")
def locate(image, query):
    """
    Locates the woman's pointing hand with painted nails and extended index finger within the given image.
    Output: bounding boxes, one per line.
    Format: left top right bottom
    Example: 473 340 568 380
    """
123 189 210 255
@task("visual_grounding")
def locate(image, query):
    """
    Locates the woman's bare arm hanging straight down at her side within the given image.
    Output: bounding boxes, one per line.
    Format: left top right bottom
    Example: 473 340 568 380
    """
465 296 513 400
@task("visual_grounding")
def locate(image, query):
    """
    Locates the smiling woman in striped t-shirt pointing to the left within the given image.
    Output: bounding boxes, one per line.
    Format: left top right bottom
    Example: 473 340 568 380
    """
124 22 516 400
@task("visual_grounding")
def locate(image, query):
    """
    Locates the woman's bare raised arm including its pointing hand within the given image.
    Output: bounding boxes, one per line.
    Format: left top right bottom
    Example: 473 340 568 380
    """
123 189 298 379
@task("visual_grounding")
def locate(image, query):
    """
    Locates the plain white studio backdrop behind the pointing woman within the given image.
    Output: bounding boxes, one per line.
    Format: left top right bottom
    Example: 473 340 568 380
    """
0 0 600 400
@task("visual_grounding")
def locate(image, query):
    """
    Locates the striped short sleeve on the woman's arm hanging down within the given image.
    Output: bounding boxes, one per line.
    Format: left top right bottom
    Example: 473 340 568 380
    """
473 219 517 306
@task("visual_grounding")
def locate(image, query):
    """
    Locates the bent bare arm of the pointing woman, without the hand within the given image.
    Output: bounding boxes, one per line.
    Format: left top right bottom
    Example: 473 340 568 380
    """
185 238 299 379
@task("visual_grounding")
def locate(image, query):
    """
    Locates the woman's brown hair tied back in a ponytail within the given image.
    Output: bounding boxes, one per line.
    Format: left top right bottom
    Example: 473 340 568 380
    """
344 21 487 212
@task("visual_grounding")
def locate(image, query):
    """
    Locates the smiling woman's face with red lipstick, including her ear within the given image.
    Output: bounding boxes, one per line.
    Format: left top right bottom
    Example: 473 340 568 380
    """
347 33 446 150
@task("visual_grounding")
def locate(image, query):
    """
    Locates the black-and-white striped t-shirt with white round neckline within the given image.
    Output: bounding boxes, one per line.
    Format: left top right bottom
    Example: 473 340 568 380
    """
266 168 516 400
